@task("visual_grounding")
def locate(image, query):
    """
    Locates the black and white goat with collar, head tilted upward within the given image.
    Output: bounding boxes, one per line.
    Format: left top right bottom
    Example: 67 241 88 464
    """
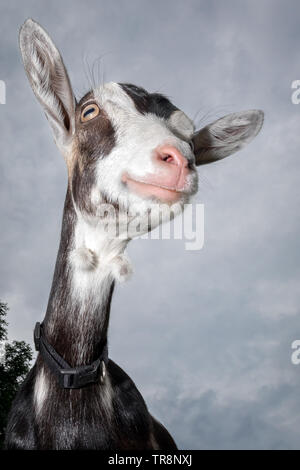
5 19 263 450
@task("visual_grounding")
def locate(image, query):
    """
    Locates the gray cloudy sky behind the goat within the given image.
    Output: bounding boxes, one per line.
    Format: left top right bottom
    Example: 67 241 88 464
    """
0 0 300 449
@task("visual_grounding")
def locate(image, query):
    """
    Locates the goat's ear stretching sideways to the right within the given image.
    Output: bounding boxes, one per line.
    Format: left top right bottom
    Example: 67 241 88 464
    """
193 109 264 165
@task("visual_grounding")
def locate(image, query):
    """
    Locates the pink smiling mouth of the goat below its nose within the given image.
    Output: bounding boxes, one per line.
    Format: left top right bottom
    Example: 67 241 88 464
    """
122 173 183 202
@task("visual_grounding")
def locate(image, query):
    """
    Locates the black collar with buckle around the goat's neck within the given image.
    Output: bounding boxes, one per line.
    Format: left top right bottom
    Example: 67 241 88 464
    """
33 323 108 388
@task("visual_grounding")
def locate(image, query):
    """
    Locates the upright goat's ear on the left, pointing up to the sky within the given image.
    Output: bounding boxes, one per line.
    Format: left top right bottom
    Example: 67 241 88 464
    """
19 19 75 149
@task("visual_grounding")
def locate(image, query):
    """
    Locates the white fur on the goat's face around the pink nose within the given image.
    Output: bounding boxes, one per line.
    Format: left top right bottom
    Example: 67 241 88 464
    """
94 83 197 218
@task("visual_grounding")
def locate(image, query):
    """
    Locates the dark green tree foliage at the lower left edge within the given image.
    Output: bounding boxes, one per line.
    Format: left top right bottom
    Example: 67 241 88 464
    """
0 302 32 448
